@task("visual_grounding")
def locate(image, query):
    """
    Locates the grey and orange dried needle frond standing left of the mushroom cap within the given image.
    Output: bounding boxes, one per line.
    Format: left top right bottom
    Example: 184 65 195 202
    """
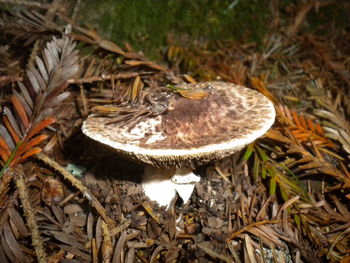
0 29 78 173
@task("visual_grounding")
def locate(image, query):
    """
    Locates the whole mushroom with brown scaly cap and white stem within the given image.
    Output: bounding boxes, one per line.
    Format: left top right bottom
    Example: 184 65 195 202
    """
82 81 275 206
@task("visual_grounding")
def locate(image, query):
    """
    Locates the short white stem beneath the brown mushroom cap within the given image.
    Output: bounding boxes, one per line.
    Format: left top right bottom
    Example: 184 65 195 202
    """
142 165 200 207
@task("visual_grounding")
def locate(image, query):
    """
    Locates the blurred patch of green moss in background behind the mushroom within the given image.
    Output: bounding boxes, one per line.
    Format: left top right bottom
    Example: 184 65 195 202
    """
80 0 270 58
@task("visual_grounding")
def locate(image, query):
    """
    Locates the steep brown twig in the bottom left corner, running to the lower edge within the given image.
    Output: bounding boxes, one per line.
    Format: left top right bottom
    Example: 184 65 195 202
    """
9 165 47 263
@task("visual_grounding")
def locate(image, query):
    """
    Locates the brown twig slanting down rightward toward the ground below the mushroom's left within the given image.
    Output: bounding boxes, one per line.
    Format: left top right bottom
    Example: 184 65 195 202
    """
36 153 116 228
